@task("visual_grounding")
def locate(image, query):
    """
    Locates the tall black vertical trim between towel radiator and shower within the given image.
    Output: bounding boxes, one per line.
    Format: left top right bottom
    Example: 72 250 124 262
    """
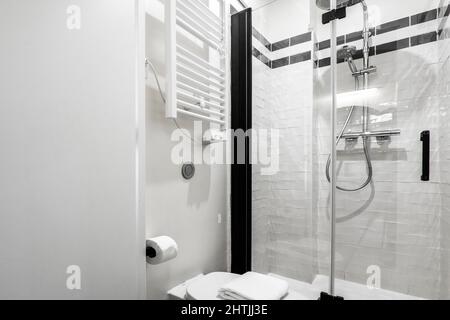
231 8 252 274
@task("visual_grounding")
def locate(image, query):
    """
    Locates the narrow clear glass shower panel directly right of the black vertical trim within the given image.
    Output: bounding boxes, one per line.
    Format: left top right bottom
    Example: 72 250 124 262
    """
252 0 330 299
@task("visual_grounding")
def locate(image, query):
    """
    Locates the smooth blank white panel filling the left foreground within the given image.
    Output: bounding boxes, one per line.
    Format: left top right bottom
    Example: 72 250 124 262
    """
0 0 145 299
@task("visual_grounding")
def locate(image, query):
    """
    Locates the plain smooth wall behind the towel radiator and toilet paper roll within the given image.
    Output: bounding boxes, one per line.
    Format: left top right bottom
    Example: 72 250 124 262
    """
146 0 228 299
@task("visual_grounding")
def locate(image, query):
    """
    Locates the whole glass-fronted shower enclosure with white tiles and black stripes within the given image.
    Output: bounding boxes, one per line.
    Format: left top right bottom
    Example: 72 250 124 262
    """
250 0 450 299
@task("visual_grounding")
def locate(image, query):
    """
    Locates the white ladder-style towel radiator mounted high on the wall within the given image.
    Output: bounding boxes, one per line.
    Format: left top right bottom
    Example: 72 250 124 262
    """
165 0 230 130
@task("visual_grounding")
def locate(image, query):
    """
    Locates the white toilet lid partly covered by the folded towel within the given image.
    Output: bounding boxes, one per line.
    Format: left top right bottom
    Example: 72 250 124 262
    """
186 272 239 300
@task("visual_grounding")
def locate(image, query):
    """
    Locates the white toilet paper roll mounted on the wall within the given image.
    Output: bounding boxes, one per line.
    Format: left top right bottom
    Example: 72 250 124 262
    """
147 236 178 265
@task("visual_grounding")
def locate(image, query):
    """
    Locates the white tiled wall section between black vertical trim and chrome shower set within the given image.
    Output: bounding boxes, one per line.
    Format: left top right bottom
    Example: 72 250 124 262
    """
253 1 317 281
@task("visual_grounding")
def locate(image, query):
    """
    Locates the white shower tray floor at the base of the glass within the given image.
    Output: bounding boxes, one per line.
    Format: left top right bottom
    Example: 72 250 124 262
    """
269 274 423 300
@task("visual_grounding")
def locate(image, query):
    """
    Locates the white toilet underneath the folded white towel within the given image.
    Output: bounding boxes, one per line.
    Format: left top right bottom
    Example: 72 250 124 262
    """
168 272 308 300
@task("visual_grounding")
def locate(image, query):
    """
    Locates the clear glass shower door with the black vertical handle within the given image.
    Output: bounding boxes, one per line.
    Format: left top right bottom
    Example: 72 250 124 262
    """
330 0 450 299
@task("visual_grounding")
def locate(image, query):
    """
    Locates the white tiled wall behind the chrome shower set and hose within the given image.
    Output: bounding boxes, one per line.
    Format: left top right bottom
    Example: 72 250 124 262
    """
313 0 450 299
